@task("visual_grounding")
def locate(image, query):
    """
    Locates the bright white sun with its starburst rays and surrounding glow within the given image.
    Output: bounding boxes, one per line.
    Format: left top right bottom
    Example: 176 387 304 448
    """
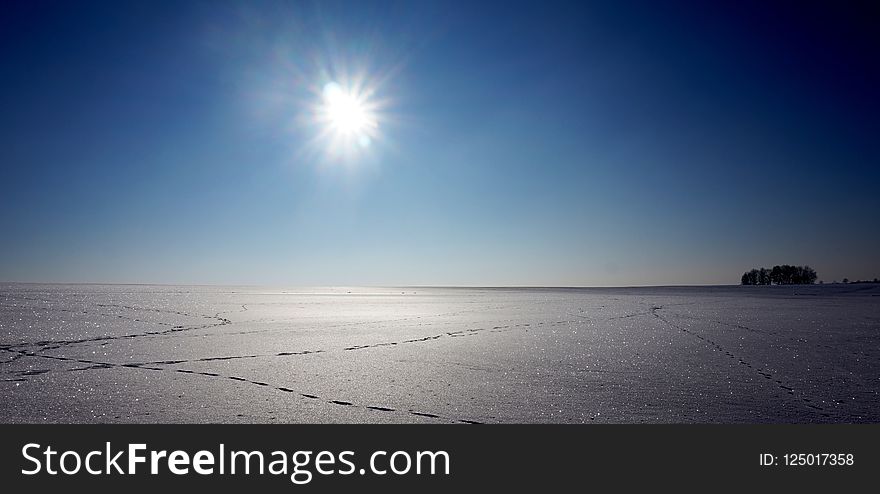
253 45 394 164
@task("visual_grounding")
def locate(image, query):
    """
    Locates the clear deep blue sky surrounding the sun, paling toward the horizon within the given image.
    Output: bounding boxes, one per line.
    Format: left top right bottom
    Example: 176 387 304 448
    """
0 1 880 285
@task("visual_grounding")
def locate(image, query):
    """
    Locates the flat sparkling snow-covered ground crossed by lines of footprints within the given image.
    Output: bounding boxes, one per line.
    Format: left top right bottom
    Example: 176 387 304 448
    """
0 284 880 423
